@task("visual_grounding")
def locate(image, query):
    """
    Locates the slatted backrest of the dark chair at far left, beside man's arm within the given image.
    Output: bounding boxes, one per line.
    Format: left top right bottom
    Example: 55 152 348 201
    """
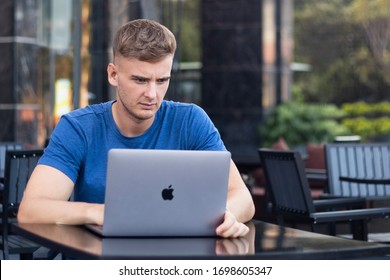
3 150 43 214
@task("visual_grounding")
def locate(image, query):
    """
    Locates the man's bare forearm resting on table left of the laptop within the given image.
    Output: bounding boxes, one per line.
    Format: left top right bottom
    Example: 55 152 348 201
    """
18 198 104 225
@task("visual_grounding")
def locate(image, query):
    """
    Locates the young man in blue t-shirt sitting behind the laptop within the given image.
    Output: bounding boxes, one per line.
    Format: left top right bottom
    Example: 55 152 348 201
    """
18 19 254 237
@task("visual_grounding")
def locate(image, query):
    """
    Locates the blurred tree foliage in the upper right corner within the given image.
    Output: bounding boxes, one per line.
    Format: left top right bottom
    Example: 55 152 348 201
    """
294 0 390 104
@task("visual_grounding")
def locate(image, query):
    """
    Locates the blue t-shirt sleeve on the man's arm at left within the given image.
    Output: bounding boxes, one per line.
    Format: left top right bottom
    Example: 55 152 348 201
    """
39 117 86 183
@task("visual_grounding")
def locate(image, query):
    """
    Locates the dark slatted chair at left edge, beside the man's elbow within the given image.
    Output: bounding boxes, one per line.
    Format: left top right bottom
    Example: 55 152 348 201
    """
0 150 43 259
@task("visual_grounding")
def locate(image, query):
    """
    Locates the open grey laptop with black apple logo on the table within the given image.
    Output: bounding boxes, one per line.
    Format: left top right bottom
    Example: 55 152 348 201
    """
88 149 231 237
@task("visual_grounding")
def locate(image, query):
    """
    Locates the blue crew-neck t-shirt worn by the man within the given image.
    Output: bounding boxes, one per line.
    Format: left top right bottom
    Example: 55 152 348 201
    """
39 101 226 203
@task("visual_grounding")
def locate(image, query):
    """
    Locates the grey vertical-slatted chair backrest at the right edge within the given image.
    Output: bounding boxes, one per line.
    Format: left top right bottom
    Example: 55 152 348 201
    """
325 143 390 199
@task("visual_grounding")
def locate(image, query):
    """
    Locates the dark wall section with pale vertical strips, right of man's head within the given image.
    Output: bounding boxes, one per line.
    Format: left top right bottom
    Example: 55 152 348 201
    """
202 0 292 162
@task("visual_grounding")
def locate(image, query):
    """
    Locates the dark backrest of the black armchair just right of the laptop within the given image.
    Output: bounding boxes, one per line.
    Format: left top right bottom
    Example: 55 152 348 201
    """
258 149 315 219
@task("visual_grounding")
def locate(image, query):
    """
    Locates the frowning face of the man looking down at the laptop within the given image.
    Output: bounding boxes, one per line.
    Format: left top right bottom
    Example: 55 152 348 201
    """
107 56 173 122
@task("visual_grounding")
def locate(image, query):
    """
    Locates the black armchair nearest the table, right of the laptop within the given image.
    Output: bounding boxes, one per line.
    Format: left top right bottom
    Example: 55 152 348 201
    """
259 149 390 241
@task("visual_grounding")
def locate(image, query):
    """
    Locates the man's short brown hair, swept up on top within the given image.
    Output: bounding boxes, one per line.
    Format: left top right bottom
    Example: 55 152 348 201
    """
113 19 176 62
